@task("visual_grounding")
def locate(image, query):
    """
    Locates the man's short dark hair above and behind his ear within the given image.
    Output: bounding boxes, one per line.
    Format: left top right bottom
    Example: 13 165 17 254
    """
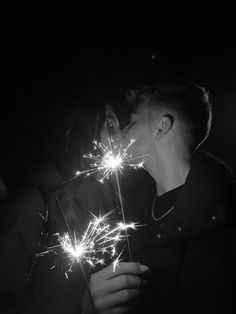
128 80 212 150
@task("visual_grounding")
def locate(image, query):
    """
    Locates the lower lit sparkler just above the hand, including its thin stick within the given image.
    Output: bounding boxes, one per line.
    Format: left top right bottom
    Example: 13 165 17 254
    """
37 196 141 308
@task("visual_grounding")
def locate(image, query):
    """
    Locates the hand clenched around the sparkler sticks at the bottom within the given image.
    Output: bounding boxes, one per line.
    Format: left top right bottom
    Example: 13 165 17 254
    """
82 262 149 314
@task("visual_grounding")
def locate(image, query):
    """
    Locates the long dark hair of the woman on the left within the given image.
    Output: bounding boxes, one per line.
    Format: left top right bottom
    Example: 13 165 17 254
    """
50 100 115 234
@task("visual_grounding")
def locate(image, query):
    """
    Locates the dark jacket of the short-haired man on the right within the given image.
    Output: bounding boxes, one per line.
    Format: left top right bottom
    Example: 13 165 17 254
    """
124 152 236 314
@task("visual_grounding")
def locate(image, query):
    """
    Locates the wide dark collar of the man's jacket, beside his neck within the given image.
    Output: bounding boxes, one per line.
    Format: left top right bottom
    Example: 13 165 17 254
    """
158 151 230 240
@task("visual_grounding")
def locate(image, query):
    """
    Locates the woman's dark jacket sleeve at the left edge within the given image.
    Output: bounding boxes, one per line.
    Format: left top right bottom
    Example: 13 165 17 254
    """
0 189 47 313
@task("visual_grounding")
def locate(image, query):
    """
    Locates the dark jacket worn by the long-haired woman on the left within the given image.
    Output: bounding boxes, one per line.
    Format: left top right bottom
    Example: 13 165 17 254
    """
0 177 113 314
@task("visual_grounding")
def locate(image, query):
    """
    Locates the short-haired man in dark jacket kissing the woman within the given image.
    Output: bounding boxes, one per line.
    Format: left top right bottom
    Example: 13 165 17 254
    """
87 81 234 314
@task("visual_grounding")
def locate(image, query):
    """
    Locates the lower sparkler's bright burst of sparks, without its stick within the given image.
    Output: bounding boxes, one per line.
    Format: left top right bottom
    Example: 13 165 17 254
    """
38 211 138 271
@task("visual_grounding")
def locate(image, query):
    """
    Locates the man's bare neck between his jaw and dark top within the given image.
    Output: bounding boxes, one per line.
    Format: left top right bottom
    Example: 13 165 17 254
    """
146 155 191 195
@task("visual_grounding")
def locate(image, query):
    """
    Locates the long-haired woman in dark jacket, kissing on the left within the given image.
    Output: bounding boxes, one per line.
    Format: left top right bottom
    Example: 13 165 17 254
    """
0 104 146 314
